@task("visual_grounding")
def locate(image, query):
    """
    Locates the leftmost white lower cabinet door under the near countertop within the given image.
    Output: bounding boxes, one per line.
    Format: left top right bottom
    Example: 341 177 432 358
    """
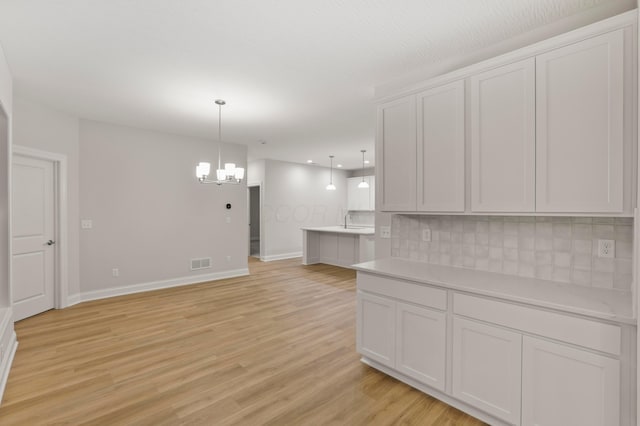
356 291 395 367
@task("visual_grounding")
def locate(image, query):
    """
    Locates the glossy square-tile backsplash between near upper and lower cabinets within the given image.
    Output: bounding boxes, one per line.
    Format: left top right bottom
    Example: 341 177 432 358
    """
391 215 633 290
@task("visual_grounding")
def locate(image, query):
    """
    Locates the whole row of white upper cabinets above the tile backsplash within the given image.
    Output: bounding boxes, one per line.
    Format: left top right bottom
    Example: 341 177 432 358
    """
376 15 638 216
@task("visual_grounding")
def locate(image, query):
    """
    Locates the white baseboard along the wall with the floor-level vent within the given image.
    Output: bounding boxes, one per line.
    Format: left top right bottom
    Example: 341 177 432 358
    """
70 268 249 305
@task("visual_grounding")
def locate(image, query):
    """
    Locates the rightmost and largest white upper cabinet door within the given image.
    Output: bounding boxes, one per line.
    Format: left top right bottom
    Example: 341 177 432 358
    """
536 30 624 213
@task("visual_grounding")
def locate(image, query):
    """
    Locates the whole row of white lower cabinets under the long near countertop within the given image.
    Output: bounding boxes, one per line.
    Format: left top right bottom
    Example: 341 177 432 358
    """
356 271 624 426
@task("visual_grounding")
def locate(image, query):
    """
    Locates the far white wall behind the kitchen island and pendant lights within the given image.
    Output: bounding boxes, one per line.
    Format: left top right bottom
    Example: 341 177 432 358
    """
249 160 347 260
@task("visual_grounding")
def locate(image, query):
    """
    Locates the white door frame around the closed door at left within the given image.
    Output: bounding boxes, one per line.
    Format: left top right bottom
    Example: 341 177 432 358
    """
11 145 69 309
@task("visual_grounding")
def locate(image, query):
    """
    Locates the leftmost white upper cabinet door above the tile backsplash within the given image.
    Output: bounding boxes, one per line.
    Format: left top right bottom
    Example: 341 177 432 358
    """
376 95 416 211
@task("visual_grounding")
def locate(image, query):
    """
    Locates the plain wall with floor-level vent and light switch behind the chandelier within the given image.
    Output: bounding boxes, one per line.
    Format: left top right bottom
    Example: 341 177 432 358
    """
80 120 248 298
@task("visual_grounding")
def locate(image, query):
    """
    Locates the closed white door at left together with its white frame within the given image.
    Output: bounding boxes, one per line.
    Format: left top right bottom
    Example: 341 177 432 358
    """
11 146 68 321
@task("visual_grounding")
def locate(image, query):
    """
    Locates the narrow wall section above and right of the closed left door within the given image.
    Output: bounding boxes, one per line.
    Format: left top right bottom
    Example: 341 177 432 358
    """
13 96 80 295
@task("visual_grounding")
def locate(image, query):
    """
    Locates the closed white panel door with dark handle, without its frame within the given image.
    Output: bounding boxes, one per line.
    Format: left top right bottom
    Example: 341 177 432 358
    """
11 155 55 320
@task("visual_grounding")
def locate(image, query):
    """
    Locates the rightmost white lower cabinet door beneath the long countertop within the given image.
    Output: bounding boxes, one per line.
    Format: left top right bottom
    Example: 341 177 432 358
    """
522 336 620 426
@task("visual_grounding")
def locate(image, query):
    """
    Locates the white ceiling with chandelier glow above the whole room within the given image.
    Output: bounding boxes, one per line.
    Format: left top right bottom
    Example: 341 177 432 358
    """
0 0 635 169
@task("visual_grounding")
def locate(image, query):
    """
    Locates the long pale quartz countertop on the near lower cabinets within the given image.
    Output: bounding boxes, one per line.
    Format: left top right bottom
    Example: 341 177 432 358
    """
352 258 636 325
